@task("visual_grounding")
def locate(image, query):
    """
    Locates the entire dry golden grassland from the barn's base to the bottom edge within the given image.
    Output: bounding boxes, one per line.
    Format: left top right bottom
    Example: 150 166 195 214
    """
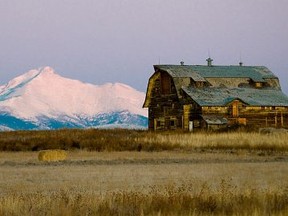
0 130 288 215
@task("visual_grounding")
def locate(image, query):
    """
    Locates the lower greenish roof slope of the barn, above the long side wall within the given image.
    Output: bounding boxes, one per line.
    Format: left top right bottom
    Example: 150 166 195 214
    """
182 87 288 106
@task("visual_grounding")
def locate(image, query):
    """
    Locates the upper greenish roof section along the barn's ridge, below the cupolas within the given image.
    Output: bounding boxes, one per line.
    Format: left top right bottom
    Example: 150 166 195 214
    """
154 65 277 82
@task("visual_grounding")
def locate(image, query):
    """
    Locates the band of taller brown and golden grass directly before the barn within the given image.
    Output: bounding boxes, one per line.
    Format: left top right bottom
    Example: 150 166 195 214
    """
0 129 288 152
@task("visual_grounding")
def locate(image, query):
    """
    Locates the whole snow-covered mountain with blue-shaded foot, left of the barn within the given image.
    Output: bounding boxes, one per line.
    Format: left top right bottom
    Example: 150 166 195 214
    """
0 67 147 130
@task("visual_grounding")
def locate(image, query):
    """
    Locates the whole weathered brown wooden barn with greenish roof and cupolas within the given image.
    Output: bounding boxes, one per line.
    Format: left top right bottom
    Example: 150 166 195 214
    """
143 58 288 130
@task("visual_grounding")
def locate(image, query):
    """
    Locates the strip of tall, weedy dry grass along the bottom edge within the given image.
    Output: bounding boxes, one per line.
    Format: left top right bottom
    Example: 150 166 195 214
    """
0 180 288 215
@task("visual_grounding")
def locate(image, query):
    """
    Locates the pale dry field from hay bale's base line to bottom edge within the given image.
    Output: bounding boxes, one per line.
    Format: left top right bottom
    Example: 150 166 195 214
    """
0 151 288 215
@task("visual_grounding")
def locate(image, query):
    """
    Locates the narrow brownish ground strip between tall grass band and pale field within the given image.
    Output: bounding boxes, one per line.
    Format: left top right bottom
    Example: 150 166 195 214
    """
0 151 288 167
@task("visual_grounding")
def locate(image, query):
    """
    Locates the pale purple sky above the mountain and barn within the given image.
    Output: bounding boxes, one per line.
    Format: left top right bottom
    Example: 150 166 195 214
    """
0 0 288 93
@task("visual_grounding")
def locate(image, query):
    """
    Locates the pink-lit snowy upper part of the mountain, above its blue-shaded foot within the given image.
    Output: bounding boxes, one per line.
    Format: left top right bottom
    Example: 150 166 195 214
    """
0 67 147 124
